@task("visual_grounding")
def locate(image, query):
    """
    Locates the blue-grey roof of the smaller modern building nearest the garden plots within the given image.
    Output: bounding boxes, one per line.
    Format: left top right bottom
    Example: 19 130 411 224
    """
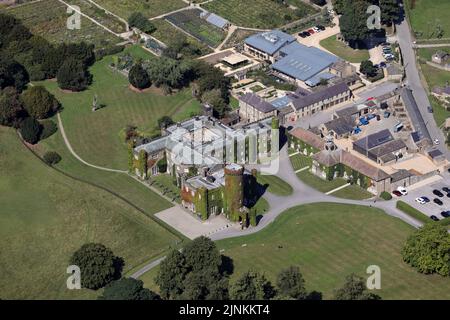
245 30 295 55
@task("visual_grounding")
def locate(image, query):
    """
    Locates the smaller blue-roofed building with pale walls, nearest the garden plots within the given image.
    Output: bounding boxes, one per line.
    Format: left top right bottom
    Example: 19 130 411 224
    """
244 30 296 63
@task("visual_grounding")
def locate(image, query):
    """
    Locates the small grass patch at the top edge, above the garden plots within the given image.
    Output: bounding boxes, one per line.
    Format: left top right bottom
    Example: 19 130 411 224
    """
90 0 187 19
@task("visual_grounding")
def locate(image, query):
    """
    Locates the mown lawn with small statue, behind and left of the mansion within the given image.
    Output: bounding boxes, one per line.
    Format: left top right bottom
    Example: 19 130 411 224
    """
35 57 200 170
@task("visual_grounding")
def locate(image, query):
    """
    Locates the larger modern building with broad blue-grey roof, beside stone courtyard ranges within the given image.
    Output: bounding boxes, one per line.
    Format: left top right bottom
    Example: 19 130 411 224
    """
272 42 339 86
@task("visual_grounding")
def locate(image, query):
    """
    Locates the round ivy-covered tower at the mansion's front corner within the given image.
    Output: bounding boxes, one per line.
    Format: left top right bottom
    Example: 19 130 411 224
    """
224 164 244 221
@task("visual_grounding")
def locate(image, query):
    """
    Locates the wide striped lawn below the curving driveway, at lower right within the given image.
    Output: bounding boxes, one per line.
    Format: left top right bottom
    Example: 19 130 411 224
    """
217 203 450 299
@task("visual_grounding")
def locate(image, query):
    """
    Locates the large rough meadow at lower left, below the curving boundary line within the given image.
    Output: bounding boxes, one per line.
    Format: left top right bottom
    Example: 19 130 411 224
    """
0 127 179 299
